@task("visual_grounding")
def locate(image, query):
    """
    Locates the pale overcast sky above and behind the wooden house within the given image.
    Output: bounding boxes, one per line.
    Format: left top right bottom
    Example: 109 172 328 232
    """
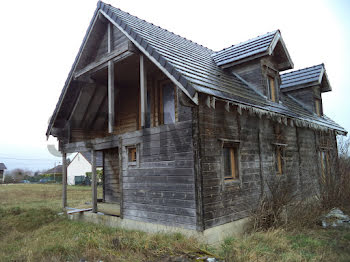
0 0 350 170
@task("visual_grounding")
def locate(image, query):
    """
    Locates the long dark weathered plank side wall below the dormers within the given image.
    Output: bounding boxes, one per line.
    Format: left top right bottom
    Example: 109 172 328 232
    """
198 96 335 228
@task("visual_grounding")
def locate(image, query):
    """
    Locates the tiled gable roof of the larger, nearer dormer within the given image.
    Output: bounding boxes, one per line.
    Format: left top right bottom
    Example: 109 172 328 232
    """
212 30 293 70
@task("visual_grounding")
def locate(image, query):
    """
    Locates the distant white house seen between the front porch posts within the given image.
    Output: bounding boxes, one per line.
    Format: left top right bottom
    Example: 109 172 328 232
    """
67 152 103 185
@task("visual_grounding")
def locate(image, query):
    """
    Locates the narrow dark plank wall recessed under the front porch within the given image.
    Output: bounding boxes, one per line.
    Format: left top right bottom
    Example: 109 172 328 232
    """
103 148 120 203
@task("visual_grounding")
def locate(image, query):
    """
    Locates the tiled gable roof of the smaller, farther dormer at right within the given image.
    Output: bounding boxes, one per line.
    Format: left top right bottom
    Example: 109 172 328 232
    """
281 64 332 92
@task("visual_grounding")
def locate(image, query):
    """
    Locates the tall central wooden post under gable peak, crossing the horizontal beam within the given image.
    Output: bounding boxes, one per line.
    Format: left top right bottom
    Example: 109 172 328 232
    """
108 23 115 133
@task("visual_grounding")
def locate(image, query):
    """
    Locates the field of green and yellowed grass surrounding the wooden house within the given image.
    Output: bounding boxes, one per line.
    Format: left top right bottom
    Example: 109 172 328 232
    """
0 184 350 262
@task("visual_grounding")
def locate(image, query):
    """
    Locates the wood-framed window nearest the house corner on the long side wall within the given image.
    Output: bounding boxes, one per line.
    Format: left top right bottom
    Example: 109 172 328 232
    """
222 145 239 180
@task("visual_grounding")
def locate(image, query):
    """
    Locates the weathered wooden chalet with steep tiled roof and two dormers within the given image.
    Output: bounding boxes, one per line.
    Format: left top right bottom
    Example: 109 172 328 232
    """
46 2 346 244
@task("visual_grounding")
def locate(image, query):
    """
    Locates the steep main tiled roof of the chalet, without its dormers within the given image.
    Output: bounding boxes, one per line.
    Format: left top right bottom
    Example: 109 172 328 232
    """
46 1 345 136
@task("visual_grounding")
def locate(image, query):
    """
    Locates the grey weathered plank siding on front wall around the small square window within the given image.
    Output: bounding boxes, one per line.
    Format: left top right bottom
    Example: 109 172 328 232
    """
122 120 196 229
